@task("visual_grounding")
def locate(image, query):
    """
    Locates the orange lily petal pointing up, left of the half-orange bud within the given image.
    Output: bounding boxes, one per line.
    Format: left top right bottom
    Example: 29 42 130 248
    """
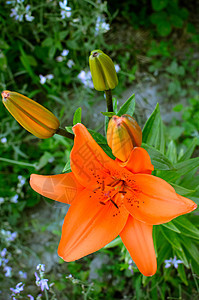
70 124 122 187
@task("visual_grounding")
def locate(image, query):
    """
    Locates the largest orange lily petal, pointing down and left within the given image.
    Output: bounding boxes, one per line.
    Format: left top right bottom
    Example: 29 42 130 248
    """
58 189 129 262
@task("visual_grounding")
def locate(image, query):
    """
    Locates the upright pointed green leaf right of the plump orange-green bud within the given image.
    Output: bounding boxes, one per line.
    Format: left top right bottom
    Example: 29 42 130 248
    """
142 103 165 153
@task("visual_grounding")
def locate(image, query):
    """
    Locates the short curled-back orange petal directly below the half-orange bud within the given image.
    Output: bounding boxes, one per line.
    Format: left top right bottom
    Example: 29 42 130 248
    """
116 147 154 174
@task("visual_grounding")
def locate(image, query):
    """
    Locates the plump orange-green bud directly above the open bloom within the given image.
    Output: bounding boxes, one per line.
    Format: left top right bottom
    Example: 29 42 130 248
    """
107 115 142 162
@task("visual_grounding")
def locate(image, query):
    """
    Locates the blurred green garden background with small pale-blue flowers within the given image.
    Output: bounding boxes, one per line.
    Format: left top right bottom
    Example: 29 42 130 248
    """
0 0 199 300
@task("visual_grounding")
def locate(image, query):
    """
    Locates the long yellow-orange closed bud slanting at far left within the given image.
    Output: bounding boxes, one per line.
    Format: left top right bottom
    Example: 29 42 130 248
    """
1 91 60 139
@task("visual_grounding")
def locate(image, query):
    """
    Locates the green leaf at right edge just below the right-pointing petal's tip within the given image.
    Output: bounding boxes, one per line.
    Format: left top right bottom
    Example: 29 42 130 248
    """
173 216 199 240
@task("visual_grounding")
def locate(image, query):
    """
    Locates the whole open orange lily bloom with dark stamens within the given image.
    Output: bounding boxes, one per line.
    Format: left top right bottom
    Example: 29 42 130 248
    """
30 124 196 276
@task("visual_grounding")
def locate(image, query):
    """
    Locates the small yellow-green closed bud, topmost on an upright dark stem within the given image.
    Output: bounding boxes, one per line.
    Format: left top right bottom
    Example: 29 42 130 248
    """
89 50 118 91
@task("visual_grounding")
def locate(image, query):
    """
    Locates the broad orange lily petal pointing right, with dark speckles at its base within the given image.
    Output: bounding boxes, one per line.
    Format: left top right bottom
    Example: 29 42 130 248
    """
124 174 197 225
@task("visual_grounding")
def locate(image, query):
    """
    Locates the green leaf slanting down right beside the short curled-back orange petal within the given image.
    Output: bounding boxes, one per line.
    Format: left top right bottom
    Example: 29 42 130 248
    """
142 143 175 170
